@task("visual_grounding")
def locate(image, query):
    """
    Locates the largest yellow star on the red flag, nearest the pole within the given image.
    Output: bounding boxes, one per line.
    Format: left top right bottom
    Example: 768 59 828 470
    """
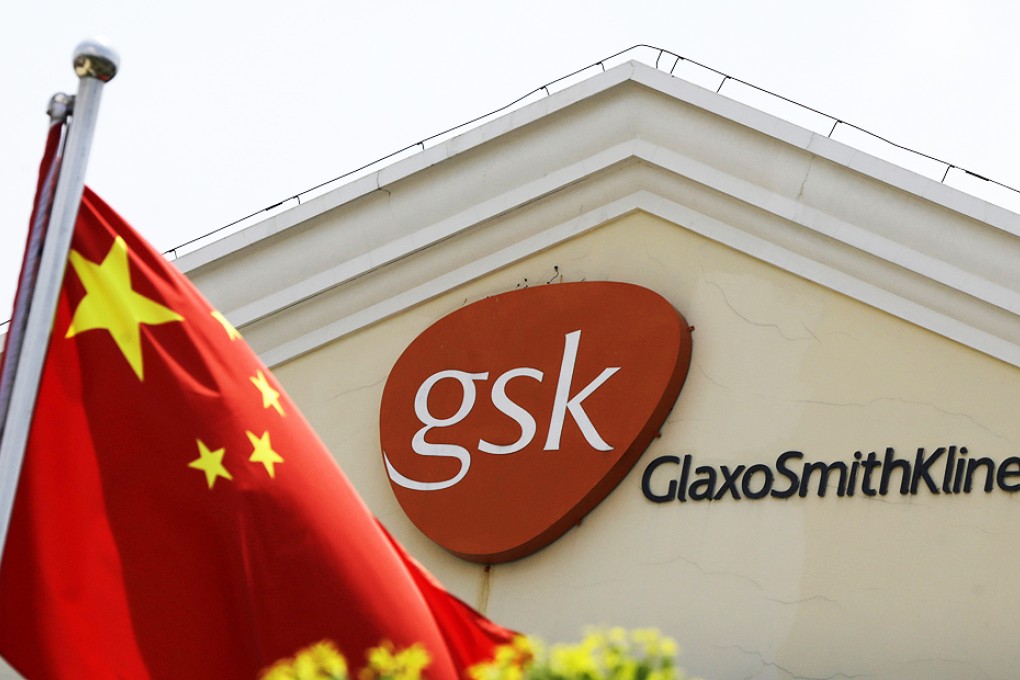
64 237 184 380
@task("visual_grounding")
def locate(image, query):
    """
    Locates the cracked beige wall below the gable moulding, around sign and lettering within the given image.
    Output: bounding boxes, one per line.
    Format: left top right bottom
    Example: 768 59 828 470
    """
275 213 1020 678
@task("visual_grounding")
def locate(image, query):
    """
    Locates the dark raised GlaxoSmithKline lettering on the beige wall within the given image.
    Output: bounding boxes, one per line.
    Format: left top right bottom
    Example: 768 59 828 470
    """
642 446 1020 503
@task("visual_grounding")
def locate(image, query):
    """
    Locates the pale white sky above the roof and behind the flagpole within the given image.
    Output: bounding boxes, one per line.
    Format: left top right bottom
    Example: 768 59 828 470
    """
0 0 1020 320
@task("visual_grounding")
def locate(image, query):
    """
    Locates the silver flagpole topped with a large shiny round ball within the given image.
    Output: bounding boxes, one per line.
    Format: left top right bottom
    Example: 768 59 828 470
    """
0 41 120 560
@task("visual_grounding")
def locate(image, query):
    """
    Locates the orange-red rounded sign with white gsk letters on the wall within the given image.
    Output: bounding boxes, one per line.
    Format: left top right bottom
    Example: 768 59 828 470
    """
379 282 691 564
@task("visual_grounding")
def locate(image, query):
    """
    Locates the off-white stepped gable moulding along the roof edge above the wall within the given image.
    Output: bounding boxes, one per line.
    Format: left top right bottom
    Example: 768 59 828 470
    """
177 62 1020 366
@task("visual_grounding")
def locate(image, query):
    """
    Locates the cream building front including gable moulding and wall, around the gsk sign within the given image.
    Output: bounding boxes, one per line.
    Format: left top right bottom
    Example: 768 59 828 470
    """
179 62 1020 679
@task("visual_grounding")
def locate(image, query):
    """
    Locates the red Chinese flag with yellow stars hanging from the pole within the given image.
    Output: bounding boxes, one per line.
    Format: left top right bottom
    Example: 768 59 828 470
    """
0 183 512 679
